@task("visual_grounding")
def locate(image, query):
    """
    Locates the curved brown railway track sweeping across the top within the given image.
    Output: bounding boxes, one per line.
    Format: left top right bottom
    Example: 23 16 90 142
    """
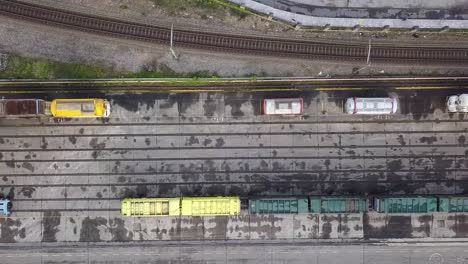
0 0 468 66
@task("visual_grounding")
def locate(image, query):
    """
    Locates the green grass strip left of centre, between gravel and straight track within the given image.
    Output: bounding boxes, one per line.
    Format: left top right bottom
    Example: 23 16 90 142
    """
0 55 216 80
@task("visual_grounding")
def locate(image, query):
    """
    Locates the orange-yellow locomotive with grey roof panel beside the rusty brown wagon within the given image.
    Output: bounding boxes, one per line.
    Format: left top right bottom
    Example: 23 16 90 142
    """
50 99 110 117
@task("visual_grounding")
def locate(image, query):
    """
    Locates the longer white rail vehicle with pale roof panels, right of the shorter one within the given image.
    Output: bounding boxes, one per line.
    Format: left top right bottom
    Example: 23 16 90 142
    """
345 97 398 115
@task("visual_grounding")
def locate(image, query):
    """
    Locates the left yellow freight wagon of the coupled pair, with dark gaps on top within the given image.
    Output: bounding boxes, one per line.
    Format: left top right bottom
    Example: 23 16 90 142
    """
121 198 180 217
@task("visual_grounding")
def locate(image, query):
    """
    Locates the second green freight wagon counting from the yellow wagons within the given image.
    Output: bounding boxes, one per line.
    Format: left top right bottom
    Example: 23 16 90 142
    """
309 197 368 214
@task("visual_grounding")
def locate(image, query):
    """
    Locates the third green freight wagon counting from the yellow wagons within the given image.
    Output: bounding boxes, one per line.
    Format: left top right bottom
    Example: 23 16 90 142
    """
373 197 437 214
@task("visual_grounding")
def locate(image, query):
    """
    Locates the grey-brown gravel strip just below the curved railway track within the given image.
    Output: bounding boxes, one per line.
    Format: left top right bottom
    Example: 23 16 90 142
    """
0 1 466 78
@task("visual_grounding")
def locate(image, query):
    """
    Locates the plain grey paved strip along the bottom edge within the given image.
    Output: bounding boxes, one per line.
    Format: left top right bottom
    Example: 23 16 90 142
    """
0 243 468 264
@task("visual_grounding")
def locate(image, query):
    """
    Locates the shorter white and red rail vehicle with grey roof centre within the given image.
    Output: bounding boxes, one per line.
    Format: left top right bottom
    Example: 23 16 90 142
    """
263 98 304 115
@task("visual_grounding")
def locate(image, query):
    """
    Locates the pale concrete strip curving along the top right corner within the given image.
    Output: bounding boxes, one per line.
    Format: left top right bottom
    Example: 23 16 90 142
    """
230 0 468 29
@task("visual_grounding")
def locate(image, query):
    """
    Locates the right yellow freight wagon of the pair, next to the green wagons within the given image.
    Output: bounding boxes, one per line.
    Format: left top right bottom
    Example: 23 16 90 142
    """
181 197 240 216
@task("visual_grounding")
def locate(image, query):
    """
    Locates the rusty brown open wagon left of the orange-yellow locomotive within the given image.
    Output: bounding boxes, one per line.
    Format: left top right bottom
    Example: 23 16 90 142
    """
0 99 50 118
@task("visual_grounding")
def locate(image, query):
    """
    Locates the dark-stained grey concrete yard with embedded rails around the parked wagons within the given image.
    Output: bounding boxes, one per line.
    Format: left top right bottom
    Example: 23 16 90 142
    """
0 90 468 242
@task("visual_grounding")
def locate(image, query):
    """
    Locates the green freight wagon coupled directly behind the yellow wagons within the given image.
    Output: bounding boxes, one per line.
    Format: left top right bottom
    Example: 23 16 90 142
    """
249 198 309 214
